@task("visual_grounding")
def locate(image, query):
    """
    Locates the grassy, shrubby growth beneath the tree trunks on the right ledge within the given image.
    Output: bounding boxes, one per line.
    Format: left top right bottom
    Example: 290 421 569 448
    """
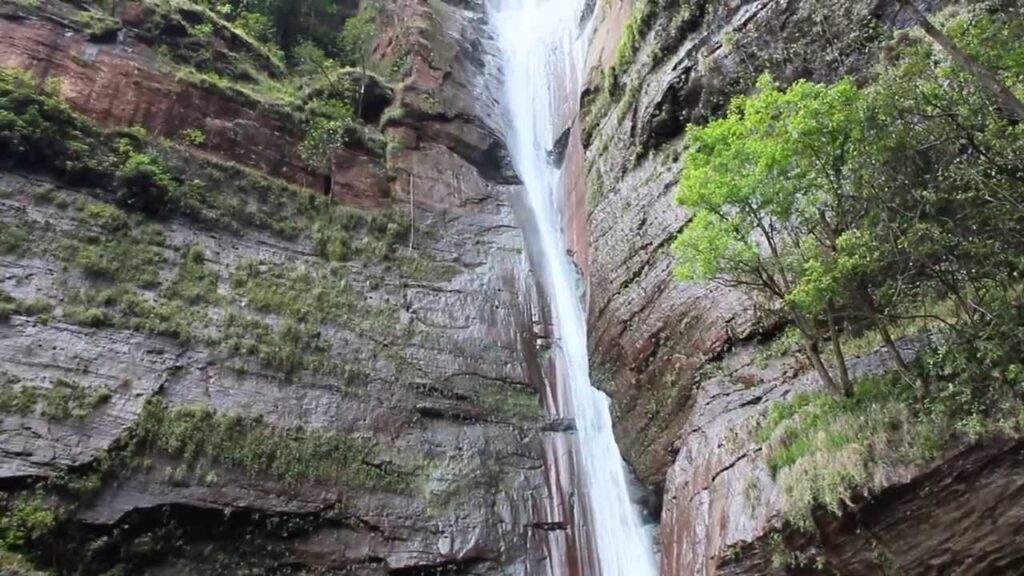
756 297 1024 529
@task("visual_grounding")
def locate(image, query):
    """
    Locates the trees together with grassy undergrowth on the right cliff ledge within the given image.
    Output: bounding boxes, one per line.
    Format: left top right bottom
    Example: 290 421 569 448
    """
676 2 1024 528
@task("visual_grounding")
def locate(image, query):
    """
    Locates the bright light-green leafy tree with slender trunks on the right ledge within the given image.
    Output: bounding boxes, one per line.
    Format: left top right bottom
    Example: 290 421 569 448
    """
675 77 865 394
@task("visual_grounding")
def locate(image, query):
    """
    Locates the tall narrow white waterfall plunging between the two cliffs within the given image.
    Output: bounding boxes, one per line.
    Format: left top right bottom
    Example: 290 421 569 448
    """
490 0 657 576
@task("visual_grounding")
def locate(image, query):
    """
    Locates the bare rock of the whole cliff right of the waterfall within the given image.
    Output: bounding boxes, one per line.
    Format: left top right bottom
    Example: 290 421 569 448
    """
574 0 1021 576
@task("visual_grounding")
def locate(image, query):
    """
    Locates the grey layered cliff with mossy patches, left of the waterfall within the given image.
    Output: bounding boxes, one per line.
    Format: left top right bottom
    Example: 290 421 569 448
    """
0 0 565 574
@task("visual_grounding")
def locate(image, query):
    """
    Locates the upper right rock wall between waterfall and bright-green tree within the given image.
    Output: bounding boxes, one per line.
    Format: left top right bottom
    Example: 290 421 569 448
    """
584 0 921 483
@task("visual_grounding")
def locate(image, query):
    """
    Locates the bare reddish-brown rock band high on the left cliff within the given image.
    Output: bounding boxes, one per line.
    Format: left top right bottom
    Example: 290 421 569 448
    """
0 14 323 192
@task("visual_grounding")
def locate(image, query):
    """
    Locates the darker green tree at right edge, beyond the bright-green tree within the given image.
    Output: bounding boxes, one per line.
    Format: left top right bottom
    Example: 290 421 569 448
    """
869 3 1024 326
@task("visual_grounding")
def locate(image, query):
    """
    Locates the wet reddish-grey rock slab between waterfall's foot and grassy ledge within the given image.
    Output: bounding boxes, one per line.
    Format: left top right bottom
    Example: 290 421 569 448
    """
662 338 925 575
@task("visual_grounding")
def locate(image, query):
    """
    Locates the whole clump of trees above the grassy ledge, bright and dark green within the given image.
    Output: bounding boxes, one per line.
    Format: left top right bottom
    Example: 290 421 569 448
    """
675 4 1024 394
